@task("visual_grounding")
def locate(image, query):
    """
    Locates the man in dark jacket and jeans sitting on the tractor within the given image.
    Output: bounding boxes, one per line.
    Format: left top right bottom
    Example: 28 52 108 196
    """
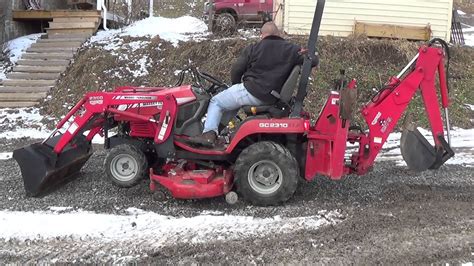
189 22 318 147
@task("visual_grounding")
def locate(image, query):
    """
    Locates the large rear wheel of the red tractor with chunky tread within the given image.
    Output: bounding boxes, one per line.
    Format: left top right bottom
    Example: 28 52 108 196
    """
234 141 299 206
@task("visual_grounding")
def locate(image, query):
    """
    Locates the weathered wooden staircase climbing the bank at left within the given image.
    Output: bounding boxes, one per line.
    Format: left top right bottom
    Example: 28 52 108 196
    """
0 11 101 108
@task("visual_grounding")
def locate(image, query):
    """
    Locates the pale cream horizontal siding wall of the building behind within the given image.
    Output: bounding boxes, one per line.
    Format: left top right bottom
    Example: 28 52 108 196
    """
283 0 453 40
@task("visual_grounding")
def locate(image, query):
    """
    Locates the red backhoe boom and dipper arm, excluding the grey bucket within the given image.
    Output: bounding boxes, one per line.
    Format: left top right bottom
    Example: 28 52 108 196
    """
352 46 449 174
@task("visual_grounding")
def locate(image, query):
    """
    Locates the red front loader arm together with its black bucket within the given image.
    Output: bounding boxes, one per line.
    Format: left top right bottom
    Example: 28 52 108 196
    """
13 90 177 196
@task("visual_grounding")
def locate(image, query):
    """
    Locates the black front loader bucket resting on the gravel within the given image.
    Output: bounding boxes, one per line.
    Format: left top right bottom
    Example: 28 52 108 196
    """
13 134 92 197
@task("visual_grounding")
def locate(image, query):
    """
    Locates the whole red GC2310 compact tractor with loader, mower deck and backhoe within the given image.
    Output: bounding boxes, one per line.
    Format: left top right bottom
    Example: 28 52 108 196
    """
14 0 454 205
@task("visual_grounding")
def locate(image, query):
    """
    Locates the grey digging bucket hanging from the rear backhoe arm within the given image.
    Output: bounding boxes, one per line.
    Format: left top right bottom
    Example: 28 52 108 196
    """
400 123 436 172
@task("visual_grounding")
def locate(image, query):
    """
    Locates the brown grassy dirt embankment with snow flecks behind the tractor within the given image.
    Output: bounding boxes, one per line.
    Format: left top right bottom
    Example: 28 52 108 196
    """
43 34 474 127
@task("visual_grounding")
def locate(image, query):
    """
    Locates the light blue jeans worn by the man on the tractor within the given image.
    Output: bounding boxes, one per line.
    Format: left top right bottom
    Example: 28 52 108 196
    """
203 83 263 134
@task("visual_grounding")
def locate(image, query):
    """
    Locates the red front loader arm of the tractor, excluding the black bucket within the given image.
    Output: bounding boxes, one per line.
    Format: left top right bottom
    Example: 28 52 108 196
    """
51 92 177 154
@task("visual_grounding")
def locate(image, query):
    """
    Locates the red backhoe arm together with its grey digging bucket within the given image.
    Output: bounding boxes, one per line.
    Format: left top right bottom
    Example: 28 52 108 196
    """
351 39 454 174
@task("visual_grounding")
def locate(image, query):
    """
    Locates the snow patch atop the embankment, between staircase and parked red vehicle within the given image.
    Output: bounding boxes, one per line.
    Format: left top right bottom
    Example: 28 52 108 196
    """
90 16 207 47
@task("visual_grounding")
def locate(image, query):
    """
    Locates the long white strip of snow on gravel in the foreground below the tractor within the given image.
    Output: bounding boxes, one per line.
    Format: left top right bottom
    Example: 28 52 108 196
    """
0 209 341 246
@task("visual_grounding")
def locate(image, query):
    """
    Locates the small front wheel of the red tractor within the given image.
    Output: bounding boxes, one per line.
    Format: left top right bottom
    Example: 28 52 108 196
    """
104 144 148 188
